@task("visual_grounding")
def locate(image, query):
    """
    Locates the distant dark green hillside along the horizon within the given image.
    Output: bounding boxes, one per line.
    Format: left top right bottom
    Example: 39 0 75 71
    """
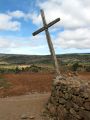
0 53 90 64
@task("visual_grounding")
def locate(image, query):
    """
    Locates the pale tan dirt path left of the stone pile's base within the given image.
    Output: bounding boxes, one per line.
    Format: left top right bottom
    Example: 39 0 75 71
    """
0 93 50 120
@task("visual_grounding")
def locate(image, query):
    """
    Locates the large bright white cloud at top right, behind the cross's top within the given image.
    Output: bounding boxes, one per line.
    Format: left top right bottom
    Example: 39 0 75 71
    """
37 0 90 29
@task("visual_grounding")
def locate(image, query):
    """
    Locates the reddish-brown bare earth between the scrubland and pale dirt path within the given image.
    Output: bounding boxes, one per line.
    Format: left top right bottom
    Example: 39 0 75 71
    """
0 72 90 97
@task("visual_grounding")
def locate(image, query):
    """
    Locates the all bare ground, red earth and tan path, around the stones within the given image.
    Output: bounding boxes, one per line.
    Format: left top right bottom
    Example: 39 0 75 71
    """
0 72 90 120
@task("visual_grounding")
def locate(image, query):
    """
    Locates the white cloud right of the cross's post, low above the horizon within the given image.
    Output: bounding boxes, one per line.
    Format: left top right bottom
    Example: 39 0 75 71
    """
55 29 90 49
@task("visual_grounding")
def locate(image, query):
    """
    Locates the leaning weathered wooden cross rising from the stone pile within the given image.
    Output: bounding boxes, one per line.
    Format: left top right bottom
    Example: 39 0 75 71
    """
33 10 60 75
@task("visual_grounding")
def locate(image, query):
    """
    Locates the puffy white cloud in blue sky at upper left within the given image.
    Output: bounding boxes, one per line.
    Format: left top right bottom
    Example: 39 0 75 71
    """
0 10 31 31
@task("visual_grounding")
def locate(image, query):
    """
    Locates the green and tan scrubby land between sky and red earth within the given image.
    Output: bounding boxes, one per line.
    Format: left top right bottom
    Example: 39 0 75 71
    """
0 53 90 74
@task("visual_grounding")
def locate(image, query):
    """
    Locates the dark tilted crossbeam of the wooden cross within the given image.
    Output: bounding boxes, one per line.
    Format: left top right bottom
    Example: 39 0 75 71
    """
32 18 60 36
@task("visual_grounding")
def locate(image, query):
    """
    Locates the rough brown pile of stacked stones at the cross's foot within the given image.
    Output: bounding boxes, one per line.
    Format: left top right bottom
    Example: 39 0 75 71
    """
43 76 90 120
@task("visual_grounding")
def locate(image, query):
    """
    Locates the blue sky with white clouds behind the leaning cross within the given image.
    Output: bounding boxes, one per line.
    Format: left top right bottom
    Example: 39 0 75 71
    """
0 0 90 55
